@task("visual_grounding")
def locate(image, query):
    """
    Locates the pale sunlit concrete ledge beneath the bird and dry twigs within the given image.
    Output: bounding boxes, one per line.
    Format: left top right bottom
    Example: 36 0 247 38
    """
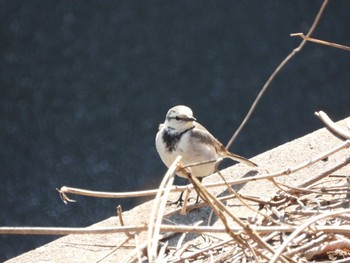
7 118 350 263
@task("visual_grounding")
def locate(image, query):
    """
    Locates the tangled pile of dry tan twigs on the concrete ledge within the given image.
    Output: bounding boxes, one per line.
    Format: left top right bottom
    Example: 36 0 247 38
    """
143 112 350 262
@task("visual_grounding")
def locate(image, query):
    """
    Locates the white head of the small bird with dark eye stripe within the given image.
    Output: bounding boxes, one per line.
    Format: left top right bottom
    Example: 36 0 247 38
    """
164 105 196 132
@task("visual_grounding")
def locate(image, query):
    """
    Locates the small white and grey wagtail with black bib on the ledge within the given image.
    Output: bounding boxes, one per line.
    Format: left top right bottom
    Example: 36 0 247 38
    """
155 105 257 204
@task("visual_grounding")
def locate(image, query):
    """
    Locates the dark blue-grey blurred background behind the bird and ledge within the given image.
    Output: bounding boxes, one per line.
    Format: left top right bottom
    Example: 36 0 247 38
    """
0 0 350 261
